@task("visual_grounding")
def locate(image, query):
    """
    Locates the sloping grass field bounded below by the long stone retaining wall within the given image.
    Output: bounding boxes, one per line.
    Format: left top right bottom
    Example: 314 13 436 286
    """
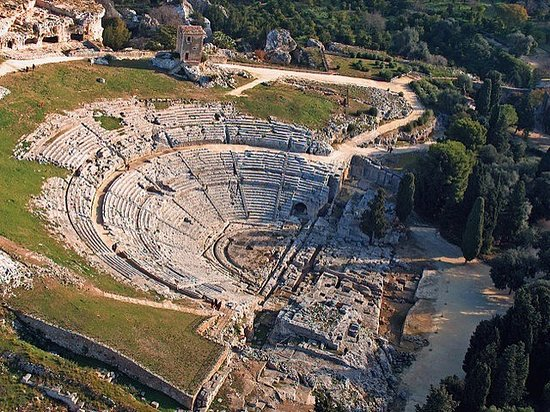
10 281 222 391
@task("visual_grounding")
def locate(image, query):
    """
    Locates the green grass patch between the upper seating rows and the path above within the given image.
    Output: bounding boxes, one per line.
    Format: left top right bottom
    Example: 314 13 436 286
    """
236 83 338 129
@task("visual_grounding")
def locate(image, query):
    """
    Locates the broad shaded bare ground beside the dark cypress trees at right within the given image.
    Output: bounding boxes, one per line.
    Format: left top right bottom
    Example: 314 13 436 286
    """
399 226 511 412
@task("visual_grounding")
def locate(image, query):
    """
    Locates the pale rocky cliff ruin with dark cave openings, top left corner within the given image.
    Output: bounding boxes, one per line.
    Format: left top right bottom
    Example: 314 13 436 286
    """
0 0 105 50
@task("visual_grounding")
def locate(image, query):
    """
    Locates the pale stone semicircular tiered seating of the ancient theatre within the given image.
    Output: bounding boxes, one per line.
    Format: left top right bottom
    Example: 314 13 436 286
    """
26 100 335 300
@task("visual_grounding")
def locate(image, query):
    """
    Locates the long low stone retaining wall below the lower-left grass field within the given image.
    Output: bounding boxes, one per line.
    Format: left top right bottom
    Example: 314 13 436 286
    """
14 311 196 409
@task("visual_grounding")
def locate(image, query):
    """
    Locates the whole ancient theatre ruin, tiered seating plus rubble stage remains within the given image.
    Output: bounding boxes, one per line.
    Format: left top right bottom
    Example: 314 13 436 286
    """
16 88 418 410
